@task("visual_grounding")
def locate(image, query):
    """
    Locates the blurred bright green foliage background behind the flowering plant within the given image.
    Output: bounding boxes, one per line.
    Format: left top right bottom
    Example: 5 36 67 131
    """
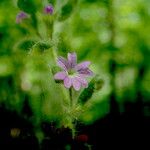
0 0 150 125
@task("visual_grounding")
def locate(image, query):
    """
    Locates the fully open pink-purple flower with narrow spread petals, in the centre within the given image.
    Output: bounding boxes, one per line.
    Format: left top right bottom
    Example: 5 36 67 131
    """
54 53 93 91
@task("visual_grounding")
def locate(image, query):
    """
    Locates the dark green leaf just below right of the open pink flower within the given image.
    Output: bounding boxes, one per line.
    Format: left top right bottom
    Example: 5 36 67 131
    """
78 75 104 105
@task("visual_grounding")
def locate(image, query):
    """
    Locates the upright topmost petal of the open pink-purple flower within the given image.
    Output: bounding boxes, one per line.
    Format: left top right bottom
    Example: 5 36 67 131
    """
68 53 77 68
